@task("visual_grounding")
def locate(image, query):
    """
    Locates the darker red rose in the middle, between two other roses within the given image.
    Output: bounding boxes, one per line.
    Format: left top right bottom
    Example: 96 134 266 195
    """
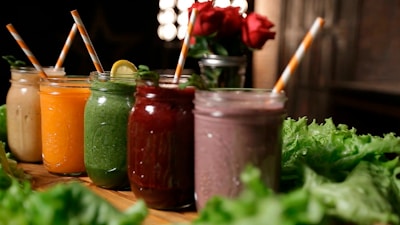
215 6 243 37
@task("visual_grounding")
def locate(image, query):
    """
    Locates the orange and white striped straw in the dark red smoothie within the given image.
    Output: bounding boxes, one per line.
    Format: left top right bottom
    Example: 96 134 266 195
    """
173 8 197 83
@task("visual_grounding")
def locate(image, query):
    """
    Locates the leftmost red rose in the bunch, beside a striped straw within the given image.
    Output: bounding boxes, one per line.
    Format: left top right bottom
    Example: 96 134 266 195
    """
189 1 224 36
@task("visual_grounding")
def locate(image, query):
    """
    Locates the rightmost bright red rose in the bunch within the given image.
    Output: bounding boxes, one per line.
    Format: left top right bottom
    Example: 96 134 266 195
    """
242 13 275 49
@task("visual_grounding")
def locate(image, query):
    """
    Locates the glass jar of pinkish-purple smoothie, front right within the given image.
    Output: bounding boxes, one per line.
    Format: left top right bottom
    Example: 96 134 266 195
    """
194 88 286 209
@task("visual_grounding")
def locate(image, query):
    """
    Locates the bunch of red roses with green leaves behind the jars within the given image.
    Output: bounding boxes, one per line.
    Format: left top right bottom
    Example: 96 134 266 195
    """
188 0 275 58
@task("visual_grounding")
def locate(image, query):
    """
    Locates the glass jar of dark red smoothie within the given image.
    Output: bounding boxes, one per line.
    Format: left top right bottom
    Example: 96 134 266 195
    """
127 76 195 210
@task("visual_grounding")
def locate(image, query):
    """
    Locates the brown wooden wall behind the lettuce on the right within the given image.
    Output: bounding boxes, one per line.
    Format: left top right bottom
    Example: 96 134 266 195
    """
278 0 400 134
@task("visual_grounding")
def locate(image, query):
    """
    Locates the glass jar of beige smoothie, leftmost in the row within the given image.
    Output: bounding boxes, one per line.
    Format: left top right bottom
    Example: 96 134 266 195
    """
6 67 65 162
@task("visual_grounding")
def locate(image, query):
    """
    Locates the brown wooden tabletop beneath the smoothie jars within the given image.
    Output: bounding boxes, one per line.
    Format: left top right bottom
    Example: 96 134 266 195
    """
18 163 197 225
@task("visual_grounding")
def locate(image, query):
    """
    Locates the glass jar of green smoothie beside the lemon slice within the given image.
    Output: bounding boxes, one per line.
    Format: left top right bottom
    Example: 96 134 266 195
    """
84 71 136 190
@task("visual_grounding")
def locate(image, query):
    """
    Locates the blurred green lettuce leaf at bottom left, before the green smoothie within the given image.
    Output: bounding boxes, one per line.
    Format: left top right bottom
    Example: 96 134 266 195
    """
25 182 147 224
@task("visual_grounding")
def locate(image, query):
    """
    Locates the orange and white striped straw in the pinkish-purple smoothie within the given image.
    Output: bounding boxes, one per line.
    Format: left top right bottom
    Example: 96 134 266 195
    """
272 17 325 93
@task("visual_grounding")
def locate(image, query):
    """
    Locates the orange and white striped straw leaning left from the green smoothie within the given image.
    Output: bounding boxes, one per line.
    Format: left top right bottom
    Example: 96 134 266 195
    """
71 9 104 73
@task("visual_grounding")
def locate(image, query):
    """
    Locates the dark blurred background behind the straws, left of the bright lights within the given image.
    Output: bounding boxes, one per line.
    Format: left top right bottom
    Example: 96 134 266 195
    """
0 0 203 104
